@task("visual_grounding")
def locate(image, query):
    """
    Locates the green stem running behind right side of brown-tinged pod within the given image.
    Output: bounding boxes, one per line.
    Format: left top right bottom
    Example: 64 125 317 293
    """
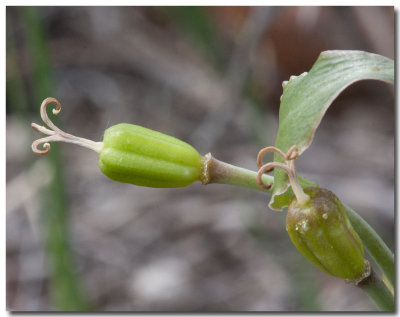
344 205 395 286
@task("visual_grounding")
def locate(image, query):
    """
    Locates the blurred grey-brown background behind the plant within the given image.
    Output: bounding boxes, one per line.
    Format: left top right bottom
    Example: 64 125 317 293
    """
6 6 395 312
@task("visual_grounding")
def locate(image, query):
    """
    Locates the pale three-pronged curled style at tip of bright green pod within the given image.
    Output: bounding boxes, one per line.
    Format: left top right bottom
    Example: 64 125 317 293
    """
31 97 103 155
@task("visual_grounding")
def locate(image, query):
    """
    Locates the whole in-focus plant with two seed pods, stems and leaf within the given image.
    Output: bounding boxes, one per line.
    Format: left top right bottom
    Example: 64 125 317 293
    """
32 51 394 311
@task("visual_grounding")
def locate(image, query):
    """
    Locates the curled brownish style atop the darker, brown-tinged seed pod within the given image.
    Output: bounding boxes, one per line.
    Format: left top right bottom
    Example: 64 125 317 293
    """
257 145 309 204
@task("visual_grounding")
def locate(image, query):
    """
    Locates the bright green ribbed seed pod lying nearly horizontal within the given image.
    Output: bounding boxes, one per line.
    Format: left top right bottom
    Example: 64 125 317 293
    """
98 123 201 187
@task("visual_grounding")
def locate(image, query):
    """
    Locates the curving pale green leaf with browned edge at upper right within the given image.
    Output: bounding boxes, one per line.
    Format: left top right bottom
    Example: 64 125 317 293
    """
269 51 394 210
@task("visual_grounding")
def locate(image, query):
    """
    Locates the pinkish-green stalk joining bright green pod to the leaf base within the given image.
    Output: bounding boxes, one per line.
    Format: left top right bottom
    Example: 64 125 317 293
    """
200 153 274 192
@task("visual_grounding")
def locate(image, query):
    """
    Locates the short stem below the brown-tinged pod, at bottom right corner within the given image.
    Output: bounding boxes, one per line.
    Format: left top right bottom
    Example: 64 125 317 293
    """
357 270 394 311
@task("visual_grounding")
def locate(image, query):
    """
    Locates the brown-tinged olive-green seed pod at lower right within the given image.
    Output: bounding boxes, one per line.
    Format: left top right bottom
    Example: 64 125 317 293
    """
286 188 364 279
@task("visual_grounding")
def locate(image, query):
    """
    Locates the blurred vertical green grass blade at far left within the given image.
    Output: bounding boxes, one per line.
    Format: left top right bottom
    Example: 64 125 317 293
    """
20 7 89 311
